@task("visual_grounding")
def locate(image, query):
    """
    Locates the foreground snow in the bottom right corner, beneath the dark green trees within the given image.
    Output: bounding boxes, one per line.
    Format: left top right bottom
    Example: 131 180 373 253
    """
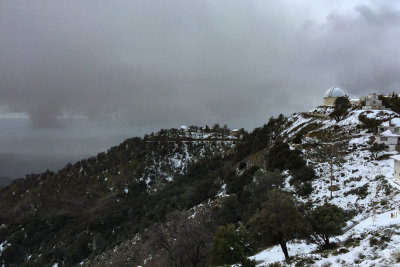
251 210 400 267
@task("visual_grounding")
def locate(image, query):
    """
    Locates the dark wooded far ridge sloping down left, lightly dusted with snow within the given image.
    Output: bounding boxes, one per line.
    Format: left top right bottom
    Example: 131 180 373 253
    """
0 127 244 265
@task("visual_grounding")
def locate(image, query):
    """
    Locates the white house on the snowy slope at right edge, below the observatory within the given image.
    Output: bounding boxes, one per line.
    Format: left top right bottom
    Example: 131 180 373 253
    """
375 118 400 151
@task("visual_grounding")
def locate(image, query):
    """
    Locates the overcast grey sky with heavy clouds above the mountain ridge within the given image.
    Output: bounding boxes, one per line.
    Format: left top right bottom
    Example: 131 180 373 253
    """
0 0 400 177
